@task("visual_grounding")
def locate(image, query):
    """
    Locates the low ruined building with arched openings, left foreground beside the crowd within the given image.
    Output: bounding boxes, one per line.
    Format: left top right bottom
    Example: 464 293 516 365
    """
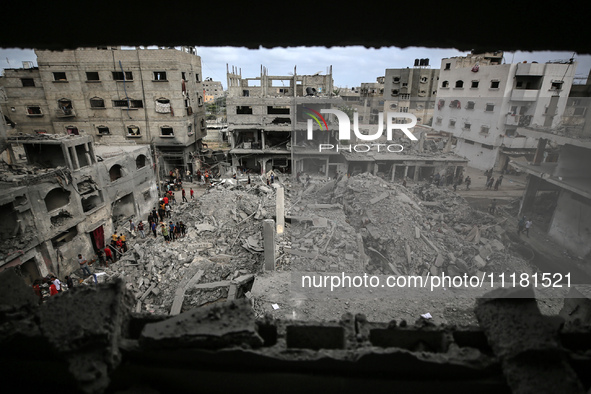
0 126 158 284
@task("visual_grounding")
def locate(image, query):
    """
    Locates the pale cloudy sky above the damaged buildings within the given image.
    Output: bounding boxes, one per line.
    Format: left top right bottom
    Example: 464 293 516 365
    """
0 46 591 89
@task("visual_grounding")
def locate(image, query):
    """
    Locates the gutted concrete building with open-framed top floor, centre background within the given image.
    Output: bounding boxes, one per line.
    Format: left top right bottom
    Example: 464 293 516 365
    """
226 67 343 174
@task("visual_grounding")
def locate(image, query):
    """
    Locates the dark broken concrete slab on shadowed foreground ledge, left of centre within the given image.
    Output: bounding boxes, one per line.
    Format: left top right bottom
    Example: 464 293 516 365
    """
139 299 263 350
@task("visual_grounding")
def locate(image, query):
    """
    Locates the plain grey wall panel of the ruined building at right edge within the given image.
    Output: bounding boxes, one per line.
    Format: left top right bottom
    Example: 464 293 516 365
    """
548 189 591 257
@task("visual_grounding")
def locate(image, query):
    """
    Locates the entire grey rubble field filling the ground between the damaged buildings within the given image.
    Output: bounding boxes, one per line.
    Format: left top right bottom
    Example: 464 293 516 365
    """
86 173 562 325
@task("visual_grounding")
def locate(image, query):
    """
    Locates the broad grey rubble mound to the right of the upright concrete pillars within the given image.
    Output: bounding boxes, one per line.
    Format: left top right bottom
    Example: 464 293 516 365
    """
294 173 531 275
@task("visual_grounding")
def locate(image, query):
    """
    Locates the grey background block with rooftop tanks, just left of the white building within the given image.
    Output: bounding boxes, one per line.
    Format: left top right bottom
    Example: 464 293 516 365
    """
383 59 439 125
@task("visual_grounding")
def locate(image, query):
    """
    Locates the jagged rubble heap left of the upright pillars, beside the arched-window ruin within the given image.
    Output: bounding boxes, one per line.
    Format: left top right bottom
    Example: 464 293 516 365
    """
94 182 282 314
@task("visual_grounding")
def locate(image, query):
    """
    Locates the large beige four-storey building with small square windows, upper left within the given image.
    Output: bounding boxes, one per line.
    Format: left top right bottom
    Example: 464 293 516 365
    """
0 46 206 173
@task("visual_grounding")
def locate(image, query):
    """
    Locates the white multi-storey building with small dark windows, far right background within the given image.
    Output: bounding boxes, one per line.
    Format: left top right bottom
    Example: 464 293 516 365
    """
433 52 576 170
